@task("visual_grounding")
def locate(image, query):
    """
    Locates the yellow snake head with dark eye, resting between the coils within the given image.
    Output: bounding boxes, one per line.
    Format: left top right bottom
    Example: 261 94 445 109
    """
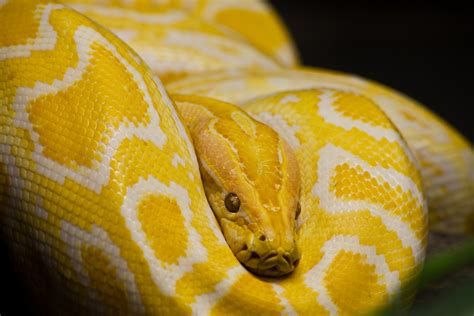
176 96 301 276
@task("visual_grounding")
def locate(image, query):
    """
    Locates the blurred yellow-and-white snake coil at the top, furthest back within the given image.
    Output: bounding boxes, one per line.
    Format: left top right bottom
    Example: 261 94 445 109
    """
64 0 296 82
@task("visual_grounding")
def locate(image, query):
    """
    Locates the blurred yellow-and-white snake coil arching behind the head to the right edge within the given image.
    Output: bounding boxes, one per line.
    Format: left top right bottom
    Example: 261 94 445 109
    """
167 68 474 234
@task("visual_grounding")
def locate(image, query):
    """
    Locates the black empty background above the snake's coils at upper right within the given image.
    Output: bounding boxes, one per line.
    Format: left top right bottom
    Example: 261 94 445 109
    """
270 0 474 142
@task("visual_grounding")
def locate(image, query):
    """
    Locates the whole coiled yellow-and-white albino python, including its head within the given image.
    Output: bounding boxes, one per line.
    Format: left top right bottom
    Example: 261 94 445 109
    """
0 0 474 315
